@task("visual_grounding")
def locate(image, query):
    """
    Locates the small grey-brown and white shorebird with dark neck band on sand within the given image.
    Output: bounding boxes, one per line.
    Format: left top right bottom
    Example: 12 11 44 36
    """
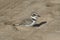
14 12 40 26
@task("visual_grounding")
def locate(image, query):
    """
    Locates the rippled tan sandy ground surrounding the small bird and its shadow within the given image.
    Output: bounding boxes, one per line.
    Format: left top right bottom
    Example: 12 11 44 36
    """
0 0 60 40
